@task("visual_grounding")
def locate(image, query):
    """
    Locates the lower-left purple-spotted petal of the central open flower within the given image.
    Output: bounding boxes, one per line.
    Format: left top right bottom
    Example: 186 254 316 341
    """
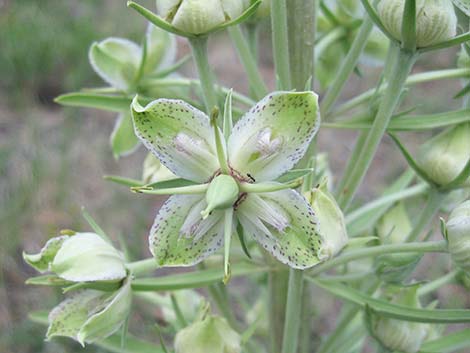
149 195 224 266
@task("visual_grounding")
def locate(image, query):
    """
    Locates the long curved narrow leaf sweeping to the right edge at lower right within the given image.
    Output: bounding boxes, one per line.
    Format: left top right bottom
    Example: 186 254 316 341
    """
306 277 470 323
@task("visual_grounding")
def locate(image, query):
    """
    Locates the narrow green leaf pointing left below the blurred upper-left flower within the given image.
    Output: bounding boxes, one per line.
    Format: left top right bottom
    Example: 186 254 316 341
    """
54 92 133 112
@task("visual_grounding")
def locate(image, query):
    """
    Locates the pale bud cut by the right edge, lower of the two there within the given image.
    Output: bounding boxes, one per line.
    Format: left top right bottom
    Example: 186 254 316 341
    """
446 200 470 275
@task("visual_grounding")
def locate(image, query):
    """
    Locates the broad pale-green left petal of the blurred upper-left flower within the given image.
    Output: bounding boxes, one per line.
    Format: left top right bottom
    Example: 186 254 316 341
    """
88 38 142 90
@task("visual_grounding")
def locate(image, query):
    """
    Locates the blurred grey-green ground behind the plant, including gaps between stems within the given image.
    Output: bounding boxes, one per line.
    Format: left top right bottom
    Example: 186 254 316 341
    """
0 0 469 353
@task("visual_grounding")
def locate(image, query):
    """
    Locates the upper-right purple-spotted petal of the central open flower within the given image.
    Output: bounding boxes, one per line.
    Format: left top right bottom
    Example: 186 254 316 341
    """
228 92 320 181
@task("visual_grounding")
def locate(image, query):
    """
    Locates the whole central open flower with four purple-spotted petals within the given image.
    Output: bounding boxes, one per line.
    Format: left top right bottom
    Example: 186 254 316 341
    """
132 92 323 279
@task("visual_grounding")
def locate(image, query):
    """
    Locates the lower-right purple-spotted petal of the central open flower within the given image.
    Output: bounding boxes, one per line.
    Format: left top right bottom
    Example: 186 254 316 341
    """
237 189 323 269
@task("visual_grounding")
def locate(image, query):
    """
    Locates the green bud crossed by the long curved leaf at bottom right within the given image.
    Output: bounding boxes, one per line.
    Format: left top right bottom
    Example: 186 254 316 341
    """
366 286 429 353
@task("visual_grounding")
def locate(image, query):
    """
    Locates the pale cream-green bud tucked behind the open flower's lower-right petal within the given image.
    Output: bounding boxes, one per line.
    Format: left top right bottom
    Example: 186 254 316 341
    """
306 181 348 259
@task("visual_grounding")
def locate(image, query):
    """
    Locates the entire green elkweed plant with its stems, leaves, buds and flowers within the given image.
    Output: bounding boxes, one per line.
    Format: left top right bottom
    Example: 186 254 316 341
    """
24 0 470 353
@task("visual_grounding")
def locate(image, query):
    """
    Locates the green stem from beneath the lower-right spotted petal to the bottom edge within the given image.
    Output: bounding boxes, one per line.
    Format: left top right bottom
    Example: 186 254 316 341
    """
282 268 304 353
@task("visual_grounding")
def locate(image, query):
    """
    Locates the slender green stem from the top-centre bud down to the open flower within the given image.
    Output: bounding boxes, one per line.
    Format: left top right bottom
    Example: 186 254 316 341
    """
189 36 218 114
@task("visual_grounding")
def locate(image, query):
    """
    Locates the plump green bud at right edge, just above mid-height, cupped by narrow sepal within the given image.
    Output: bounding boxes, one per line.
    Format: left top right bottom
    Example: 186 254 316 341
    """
417 123 470 186
